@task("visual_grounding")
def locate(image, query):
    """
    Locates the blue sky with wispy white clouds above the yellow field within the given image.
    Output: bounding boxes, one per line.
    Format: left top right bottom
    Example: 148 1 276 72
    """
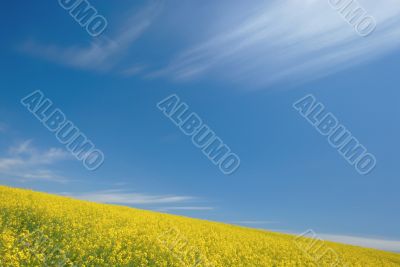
0 0 400 251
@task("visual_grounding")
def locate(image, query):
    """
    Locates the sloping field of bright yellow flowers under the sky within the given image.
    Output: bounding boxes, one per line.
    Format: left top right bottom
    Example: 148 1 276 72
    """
0 186 400 267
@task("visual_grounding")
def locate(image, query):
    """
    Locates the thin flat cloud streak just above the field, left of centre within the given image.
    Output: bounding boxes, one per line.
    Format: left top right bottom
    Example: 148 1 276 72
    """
62 190 196 205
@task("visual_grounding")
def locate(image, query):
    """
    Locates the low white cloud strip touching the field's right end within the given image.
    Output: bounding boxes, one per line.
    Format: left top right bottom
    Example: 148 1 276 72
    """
319 234 400 252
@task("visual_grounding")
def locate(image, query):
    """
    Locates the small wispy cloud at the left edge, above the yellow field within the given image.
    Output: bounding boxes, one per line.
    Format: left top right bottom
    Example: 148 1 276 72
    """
0 140 72 182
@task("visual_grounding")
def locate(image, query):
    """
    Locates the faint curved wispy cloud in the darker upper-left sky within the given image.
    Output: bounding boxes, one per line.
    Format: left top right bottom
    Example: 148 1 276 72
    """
21 1 162 71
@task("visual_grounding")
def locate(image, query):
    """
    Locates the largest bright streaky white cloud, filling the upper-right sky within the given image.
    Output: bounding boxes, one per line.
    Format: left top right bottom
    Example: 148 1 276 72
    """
157 0 400 85
